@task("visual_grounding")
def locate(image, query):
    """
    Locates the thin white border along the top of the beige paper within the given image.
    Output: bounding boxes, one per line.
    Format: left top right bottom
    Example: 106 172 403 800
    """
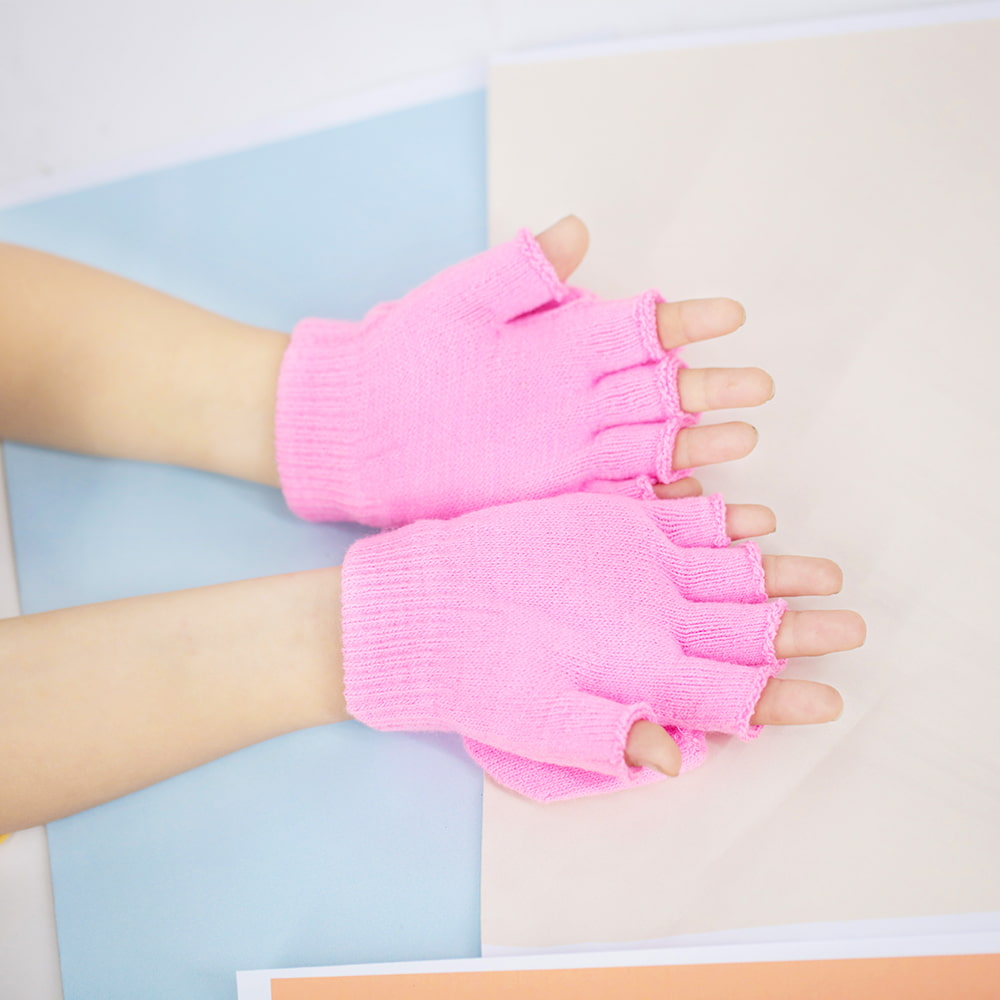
490 0 1000 66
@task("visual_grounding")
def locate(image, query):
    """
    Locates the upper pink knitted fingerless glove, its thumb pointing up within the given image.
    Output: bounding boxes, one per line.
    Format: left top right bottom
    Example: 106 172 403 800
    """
275 230 697 526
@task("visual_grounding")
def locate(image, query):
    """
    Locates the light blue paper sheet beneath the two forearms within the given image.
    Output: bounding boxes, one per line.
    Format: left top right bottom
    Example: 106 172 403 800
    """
0 92 486 1000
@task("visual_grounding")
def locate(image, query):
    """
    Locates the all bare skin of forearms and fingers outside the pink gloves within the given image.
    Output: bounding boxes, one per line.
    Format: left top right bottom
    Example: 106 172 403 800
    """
0 216 865 832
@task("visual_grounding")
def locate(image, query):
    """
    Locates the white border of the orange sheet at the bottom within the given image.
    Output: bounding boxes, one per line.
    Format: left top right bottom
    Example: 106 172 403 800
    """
236 930 1000 1000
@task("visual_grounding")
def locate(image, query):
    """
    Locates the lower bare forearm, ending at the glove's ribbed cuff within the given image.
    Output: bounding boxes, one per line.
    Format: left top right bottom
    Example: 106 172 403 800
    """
0 568 349 833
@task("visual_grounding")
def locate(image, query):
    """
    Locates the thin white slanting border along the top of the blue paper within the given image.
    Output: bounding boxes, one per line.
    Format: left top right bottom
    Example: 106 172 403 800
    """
0 65 486 210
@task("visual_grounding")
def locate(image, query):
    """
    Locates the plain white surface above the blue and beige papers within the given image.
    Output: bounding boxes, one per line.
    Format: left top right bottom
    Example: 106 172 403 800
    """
0 0 976 206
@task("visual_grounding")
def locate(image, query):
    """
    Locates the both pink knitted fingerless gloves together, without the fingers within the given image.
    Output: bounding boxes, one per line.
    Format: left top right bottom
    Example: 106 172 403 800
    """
276 230 784 800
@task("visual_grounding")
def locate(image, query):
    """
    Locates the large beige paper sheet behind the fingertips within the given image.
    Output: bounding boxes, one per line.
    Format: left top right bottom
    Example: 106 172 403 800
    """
483 21 1000 948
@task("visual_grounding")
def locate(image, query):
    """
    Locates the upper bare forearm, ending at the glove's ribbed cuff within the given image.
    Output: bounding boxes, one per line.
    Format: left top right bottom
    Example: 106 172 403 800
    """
0 244 288 485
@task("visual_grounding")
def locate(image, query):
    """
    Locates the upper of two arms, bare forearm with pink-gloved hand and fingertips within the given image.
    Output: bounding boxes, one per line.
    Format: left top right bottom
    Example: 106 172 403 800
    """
0 227 771 512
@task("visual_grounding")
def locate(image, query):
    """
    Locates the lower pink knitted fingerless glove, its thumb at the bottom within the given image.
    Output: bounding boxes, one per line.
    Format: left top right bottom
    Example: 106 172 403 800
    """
343 493 785 801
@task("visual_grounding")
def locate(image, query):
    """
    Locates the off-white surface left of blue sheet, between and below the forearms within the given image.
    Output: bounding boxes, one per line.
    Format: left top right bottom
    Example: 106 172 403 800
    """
0 447 62 1000
